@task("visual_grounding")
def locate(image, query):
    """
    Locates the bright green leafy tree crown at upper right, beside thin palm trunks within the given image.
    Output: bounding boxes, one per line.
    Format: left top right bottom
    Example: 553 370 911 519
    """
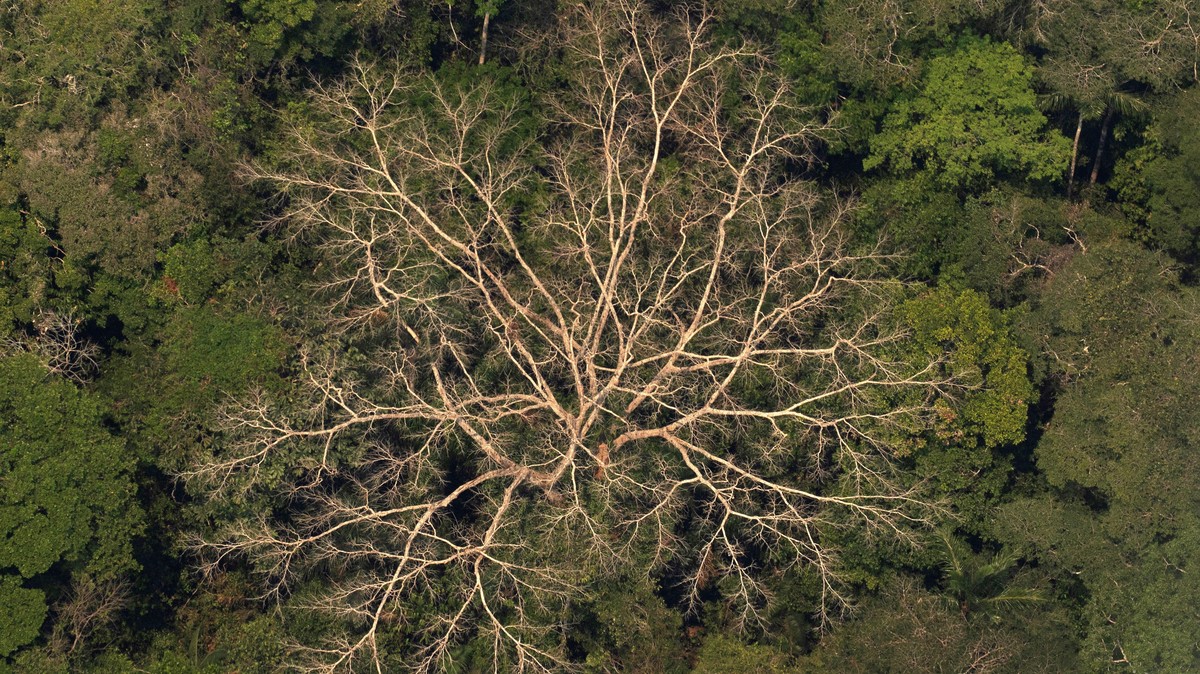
863 38 1070 189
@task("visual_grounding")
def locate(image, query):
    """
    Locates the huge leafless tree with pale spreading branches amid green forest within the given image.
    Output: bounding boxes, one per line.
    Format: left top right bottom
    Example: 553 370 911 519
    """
188 1 941 672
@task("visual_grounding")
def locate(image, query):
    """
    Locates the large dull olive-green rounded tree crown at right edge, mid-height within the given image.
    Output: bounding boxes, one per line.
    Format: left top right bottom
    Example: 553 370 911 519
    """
1030 242 1200 532
